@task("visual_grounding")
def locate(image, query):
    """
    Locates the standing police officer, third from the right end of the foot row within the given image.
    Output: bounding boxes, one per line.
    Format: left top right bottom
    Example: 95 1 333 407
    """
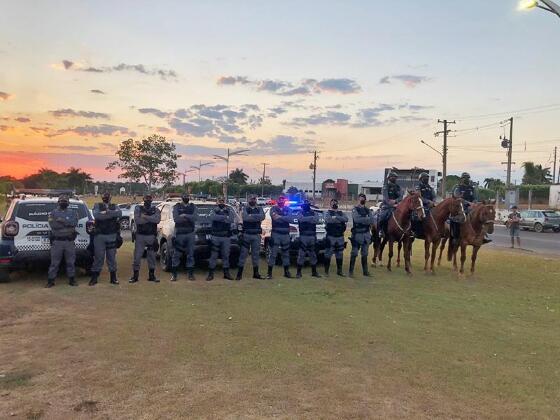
296 200 321 279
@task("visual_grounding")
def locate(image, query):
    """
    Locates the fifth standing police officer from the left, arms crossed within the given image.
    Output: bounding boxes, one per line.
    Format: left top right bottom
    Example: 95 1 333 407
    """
206 197 235 281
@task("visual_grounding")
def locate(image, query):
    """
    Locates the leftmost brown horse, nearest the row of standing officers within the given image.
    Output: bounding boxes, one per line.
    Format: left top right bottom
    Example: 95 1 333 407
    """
381 191 426 274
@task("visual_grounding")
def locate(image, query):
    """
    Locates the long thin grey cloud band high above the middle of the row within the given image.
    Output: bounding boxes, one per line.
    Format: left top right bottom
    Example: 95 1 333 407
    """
217 76 362 96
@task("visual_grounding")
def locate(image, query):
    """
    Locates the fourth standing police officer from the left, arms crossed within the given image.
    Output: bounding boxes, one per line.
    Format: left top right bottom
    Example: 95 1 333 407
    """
171 193 198 281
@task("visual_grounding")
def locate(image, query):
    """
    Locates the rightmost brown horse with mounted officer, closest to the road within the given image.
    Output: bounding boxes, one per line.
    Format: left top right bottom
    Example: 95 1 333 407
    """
440 203 496 275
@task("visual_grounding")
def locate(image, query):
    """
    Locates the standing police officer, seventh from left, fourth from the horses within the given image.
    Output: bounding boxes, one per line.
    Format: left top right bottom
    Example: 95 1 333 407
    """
266 195 294 279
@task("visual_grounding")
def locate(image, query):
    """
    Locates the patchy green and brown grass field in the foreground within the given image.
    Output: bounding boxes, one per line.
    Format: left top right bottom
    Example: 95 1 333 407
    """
0 244 560 419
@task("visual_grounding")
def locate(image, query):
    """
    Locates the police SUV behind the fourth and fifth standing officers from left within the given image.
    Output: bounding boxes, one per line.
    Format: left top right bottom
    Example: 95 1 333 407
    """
157 199 242 271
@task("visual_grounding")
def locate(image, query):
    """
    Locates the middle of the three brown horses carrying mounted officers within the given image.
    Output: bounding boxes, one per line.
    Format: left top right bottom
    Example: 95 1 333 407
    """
422 197 466 274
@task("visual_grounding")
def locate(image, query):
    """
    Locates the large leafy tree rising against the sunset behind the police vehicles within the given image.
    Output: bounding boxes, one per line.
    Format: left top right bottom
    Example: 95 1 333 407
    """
107 134 181 191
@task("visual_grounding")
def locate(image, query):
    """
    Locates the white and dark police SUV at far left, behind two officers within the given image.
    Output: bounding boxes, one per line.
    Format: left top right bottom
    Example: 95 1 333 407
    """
0 194 93 280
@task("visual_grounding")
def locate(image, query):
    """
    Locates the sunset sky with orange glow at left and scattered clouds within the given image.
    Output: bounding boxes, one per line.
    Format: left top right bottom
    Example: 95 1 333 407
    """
0 0 560 182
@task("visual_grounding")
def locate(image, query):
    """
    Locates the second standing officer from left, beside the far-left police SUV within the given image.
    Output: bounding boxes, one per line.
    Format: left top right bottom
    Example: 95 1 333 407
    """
89 192 122 286
